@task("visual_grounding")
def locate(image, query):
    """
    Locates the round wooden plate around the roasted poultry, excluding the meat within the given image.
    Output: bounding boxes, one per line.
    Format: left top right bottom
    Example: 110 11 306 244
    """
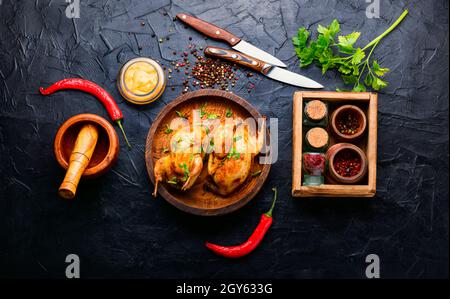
145 89 271 216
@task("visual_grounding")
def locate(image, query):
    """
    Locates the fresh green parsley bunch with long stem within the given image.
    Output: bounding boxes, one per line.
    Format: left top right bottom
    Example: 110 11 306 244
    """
292 10 408 91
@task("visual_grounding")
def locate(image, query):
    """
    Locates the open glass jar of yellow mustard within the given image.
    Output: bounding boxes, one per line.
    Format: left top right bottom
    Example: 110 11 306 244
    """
117 57 166 105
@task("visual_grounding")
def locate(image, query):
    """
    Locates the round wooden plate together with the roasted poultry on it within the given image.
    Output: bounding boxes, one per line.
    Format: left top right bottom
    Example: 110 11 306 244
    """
145 90 270 216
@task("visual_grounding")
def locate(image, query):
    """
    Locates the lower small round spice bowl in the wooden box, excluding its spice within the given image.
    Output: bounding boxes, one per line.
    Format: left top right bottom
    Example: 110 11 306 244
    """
326 143 368 184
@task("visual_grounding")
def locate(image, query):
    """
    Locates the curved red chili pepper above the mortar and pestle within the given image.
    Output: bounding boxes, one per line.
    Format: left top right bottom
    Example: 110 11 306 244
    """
39 78 131 147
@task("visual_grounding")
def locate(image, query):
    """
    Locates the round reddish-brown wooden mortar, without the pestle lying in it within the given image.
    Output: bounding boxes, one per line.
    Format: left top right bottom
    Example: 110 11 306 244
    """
54 114 119 178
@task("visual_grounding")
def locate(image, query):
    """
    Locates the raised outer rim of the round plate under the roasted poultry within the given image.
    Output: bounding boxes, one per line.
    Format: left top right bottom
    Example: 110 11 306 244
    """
145 89 271 216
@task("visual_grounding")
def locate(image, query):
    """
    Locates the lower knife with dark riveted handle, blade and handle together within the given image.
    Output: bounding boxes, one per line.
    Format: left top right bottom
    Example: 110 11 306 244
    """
204 47 323 88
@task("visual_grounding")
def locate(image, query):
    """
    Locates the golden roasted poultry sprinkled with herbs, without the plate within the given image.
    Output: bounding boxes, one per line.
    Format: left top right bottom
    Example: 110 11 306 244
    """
153 114 265 196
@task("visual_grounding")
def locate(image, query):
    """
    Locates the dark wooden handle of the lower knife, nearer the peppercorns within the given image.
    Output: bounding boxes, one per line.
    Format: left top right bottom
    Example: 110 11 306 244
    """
204 47 273 75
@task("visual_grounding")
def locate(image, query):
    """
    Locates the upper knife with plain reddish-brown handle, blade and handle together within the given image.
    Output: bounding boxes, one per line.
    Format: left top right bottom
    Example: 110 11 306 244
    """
177 13 286 67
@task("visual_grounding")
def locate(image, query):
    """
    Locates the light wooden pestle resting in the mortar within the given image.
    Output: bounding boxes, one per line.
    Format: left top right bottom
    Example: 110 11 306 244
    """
58 124 98 199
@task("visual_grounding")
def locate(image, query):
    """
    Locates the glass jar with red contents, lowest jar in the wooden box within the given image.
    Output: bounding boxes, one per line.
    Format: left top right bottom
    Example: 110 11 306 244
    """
303 152 327 186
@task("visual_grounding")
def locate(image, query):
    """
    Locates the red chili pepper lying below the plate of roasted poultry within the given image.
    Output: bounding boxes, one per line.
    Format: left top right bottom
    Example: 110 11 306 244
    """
206 188 277 258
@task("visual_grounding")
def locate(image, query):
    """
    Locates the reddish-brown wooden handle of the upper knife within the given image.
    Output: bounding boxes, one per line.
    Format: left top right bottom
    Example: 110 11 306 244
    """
177 13 241 46
